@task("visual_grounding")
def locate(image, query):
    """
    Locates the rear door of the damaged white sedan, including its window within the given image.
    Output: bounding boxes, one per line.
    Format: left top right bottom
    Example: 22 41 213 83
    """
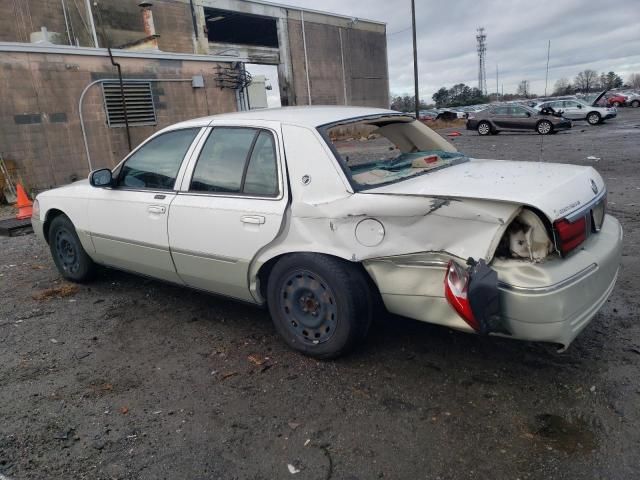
169 126 287 301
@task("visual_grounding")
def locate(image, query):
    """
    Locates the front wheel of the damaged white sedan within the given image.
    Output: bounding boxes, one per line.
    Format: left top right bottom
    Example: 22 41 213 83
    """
48 215 96 283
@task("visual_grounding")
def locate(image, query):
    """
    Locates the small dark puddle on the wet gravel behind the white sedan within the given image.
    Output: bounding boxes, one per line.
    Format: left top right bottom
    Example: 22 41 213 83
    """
531 413 597 453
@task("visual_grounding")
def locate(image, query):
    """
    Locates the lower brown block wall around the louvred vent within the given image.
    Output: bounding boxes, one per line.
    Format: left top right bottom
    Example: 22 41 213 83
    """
0 52 236 190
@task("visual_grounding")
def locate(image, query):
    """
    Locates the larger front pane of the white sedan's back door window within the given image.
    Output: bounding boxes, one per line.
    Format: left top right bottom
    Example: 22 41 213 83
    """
190 127 258 193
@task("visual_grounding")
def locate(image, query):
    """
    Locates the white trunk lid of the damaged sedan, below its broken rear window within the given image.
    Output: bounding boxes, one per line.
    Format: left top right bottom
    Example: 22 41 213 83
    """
363 159 605 221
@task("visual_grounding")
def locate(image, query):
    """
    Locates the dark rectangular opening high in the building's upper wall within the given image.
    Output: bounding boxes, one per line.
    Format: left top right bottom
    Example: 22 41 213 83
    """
204 8 278 48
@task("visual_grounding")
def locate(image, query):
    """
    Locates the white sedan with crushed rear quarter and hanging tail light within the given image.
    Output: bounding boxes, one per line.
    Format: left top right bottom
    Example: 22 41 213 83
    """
33 107 622 358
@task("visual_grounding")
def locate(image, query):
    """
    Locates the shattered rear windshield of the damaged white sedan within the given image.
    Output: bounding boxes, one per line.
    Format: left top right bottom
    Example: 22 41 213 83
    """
320 118 468 190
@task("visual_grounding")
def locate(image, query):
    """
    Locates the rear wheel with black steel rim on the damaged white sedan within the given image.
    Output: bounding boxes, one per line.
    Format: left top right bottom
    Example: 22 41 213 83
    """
267 253 372 360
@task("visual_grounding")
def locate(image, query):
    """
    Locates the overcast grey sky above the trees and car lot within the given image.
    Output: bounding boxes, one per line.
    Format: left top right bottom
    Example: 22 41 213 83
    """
249 0 640 106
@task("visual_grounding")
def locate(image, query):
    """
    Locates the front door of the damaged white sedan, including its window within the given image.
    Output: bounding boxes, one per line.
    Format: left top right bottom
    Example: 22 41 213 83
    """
89 128 200 283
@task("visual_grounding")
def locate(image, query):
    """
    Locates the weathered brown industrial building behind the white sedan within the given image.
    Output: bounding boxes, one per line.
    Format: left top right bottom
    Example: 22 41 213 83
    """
0 0 389 190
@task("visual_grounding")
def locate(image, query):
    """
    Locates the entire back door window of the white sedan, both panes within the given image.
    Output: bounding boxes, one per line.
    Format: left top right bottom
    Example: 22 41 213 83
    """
189 127 278 196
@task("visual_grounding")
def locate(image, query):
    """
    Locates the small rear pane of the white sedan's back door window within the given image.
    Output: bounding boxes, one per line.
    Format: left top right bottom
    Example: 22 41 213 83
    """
243 130 278 196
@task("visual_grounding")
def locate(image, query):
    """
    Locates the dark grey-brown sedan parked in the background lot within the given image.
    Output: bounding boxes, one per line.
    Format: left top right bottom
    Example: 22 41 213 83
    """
467 104 571 135
